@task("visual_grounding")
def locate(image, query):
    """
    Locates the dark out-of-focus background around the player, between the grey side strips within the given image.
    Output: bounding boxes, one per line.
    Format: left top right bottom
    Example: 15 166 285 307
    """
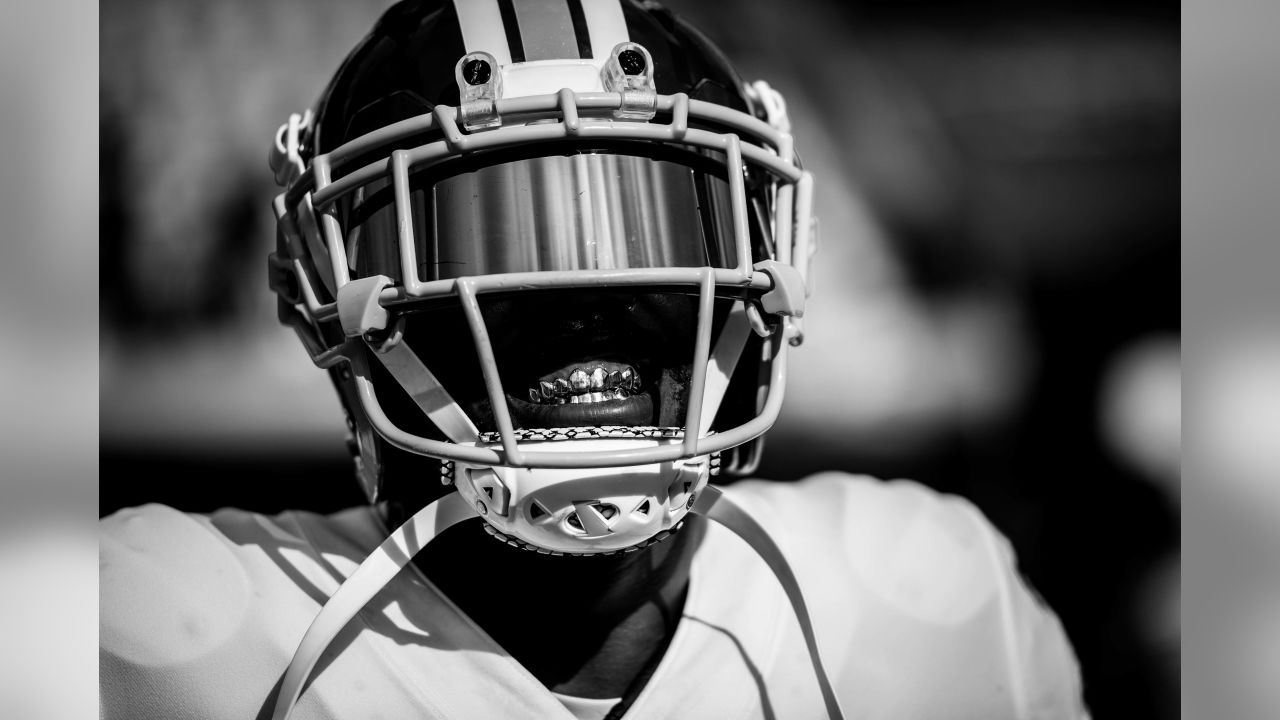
99 0 1177 717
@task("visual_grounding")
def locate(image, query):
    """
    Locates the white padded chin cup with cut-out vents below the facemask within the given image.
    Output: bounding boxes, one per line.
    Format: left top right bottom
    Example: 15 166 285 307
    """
453 430 710 555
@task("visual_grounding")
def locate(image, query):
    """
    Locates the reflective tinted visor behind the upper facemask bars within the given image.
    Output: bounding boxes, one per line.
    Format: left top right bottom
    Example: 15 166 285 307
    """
348 152 737 281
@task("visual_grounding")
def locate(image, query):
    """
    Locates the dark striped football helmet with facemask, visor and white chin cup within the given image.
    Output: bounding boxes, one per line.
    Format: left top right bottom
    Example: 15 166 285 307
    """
269 0 815 555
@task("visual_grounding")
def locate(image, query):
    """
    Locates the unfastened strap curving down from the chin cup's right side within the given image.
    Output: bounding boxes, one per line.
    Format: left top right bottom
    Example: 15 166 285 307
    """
691 486 845 720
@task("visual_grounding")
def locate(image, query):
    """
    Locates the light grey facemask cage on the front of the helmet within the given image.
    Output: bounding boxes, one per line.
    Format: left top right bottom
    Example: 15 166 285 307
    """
271 87 813 468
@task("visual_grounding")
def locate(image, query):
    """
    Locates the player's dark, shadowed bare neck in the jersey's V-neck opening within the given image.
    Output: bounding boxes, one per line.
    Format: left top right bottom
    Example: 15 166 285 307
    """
392 504 703 698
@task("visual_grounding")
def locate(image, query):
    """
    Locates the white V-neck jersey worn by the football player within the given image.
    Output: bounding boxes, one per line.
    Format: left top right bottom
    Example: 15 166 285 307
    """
100 474 1085 720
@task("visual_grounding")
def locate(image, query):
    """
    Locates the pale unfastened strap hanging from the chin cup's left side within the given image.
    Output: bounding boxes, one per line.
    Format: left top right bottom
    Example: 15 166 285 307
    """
271 492 475 720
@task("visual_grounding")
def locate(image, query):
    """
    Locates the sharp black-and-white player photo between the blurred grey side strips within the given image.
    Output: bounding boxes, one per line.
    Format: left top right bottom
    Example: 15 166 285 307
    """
87 0 1177 720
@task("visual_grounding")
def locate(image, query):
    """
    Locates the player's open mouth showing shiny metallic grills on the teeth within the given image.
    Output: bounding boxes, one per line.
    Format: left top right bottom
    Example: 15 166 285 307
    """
507 360 653 428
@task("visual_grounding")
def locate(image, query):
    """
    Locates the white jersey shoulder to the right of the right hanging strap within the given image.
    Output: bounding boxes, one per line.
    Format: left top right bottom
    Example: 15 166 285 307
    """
731 473 1087 717
